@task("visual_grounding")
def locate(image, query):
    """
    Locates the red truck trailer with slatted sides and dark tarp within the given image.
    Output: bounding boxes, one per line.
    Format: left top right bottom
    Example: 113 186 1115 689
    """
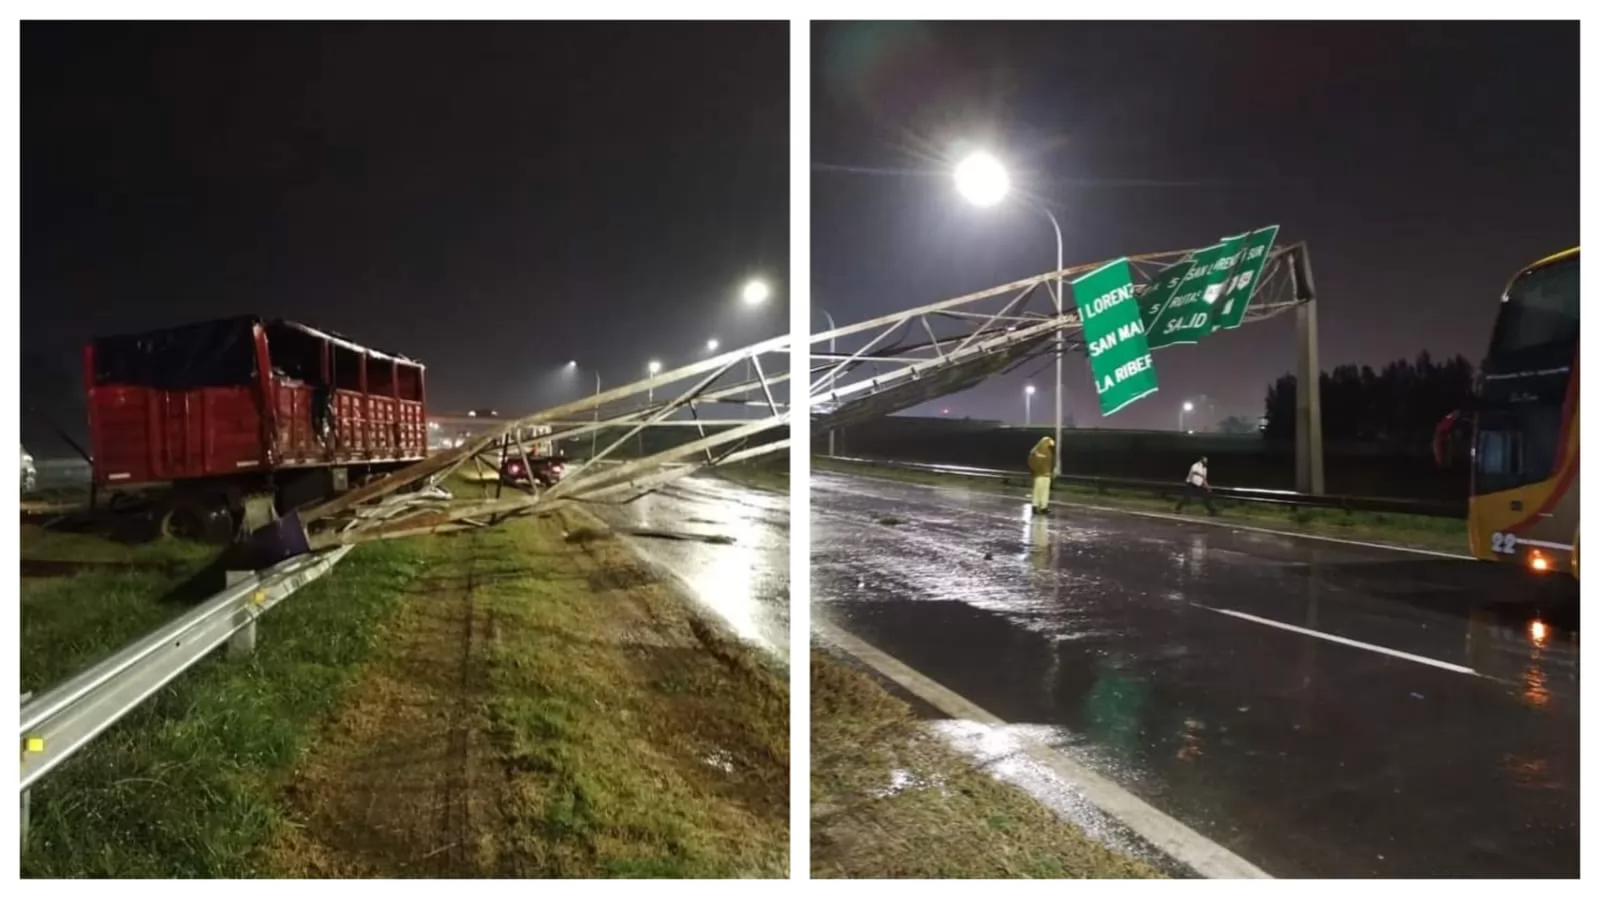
83 315 427 541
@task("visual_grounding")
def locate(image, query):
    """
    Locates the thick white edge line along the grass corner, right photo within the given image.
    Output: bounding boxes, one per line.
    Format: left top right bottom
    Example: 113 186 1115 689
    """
811 619 1272 878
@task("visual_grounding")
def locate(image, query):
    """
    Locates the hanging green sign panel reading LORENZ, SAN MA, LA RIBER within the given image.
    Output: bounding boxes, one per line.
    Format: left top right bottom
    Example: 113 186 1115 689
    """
1072 259 1155 416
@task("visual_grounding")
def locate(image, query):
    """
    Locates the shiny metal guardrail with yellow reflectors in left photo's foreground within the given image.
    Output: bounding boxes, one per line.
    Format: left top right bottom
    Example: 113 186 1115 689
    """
21 547 350 845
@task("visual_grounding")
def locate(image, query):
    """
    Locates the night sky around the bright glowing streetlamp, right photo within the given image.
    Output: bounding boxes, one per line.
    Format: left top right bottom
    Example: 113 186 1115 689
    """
811 22 1578 429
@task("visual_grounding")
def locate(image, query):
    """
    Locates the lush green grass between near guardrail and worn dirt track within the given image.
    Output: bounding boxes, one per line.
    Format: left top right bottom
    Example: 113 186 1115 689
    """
22 541 427 878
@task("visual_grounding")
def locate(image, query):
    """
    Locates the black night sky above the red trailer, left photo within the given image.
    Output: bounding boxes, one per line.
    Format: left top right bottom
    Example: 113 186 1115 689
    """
22 22 789 438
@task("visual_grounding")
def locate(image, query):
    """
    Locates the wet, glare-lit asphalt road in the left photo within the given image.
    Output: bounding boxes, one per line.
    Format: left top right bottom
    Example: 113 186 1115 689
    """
595 475 789 664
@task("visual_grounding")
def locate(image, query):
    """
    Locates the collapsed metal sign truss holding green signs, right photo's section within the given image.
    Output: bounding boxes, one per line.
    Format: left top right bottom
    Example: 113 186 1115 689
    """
810 245 1304 434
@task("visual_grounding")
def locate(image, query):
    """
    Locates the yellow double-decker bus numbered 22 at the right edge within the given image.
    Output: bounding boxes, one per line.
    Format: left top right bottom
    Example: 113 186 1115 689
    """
1467 248 1578 577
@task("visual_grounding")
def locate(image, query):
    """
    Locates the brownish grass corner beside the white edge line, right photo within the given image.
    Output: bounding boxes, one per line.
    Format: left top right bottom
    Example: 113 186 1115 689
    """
811 651 1162 878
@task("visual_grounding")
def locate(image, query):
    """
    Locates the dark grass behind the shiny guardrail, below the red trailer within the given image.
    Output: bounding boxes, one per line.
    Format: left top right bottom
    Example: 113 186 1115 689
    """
21 523 222 691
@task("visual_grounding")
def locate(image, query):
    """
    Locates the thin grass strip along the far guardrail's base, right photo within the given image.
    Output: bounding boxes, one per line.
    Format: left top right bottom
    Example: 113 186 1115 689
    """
811 457 1467 555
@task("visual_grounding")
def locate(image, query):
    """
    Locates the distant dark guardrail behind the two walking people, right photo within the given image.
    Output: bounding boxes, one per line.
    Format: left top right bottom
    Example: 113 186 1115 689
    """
819 456 1467 518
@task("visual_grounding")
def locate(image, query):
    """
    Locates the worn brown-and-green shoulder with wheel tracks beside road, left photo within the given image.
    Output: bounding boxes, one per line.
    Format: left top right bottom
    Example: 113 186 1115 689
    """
270 515 789 878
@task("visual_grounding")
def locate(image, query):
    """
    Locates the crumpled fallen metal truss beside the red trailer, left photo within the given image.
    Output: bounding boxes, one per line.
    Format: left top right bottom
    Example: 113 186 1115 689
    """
251 336 790 557
